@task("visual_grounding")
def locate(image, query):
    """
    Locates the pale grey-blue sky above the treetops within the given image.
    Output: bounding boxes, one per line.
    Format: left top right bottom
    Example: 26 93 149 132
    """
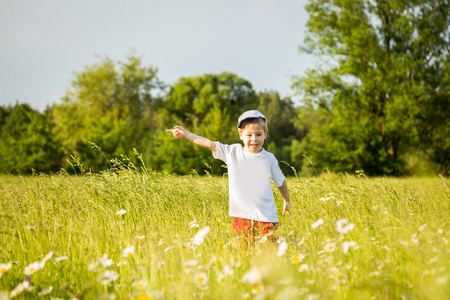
0 0 312 111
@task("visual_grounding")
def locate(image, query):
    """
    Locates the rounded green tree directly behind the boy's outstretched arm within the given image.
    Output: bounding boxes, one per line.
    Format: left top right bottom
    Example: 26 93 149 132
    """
149 72 258 174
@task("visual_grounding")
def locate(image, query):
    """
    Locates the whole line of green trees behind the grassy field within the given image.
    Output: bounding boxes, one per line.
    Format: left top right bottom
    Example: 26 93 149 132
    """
0 0 450 175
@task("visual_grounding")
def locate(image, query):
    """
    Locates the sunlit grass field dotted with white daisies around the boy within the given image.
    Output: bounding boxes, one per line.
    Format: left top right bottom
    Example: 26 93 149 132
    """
0 169 450 299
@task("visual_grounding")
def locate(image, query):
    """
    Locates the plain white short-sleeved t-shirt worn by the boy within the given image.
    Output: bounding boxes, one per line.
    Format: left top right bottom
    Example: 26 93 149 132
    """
213 142 286 223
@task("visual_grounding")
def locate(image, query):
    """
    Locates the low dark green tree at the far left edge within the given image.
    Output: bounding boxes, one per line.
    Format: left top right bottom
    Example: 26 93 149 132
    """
0 104 61 173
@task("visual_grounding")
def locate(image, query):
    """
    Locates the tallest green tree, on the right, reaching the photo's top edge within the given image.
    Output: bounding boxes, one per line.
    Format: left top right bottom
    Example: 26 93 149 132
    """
294 0 450 174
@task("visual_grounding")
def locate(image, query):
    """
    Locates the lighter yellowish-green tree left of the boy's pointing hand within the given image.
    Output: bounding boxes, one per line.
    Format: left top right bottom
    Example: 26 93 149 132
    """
53 55 162 171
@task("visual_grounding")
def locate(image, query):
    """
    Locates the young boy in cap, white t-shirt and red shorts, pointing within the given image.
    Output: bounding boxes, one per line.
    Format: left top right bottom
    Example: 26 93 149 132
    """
166 110 290 241
